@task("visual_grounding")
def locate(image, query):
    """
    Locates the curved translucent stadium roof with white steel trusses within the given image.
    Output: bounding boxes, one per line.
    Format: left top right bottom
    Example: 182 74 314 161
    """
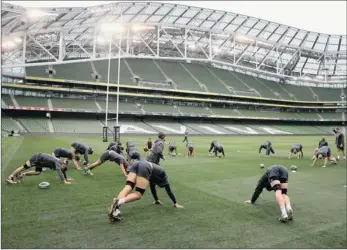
1 2 347 82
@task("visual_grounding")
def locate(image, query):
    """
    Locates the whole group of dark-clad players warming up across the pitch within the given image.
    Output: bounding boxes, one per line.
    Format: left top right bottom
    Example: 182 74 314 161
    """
7 128 346 222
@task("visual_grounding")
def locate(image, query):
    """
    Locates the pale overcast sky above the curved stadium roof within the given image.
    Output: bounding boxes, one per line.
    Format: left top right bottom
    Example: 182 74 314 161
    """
4 1 347 35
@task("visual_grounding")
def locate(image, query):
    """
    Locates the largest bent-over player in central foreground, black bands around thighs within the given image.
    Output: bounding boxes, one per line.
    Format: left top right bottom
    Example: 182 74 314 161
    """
108 161 182 222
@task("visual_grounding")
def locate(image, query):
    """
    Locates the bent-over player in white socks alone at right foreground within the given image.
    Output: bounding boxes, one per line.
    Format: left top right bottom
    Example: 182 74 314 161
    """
245 165 293 222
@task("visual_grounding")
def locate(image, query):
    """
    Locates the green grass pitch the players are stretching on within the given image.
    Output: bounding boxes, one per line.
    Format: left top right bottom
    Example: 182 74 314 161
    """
1 136 347 248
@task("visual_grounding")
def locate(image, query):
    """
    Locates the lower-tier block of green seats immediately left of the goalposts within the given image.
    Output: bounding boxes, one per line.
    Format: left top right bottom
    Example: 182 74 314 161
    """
52 118 103 134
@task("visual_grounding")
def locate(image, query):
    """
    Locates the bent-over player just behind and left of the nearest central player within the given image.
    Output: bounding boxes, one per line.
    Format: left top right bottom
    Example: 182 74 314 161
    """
83 150 129 176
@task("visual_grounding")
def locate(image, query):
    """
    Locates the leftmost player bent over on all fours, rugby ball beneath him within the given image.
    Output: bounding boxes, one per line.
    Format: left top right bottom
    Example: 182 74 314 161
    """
7 153 72 184
